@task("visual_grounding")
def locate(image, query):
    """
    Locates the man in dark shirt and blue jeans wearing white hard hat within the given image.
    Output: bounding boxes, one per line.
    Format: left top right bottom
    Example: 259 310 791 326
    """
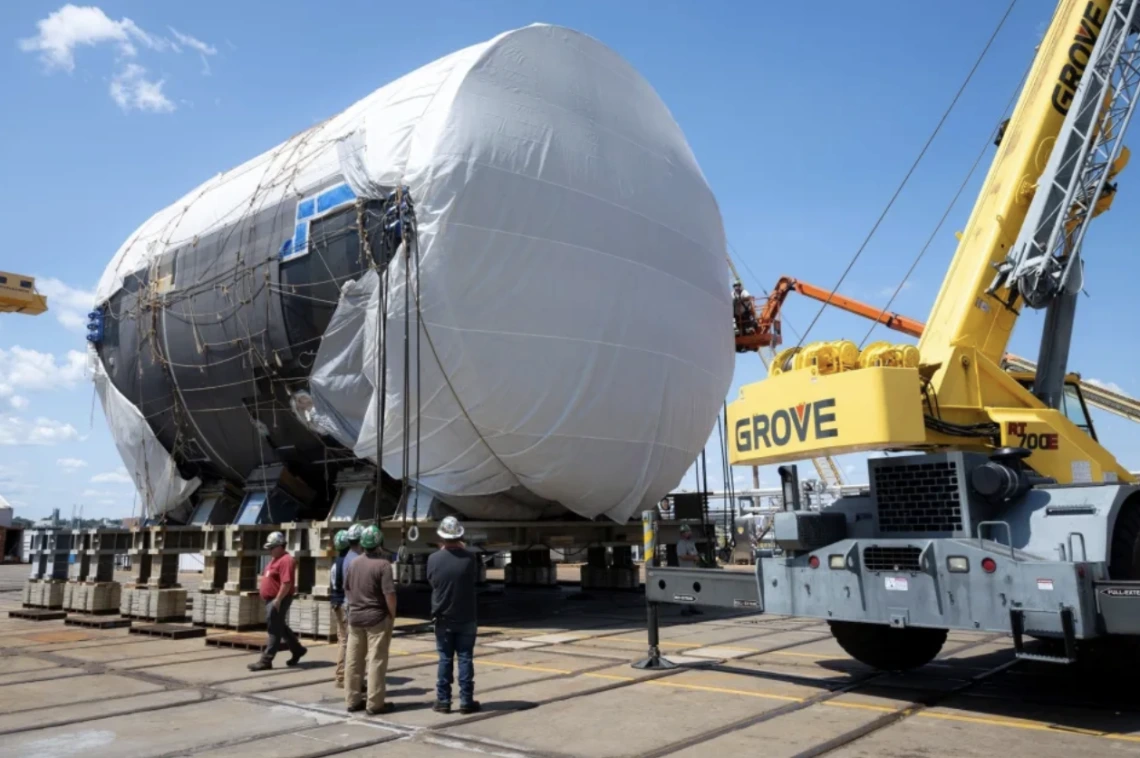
428 516 479 714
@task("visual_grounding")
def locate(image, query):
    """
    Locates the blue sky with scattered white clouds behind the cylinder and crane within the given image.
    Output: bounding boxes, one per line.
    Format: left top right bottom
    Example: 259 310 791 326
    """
0 0 1140 517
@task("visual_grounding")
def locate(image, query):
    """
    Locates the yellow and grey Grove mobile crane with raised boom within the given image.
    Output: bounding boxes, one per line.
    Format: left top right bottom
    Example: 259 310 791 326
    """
646 0 1140 669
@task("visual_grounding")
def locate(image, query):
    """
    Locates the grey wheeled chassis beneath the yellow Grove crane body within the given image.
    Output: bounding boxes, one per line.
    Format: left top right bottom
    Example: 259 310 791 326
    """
645 449 1140 669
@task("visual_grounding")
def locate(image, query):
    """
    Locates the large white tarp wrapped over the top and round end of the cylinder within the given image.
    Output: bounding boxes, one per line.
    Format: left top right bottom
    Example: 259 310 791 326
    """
97 25 734 521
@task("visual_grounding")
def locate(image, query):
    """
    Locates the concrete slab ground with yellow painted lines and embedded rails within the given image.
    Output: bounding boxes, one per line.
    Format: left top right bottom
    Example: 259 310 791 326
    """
0 567 1140 758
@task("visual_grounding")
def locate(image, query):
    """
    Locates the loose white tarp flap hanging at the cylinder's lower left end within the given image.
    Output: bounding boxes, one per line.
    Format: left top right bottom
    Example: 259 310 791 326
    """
92 360 201 517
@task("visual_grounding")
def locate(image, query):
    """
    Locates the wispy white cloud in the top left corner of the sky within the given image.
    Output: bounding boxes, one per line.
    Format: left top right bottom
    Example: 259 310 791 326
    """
18 3 218 112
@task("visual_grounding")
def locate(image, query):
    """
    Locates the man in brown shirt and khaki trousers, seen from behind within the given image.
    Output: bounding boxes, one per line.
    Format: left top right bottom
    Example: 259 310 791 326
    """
344 527 396 716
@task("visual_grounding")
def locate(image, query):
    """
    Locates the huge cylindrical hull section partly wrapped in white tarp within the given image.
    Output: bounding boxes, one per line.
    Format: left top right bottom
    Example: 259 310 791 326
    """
90 25 735 521
